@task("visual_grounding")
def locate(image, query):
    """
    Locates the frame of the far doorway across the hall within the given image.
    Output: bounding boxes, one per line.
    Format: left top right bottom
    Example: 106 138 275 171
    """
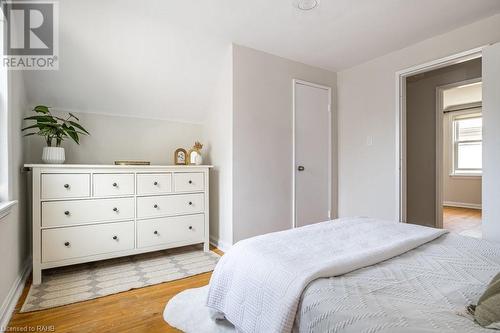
436 77 483 229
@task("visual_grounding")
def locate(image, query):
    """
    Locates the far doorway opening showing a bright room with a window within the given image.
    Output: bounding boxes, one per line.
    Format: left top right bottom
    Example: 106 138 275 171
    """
436 78 483 238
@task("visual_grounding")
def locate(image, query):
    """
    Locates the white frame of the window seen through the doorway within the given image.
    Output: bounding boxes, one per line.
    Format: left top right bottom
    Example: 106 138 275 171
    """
450 106 483 177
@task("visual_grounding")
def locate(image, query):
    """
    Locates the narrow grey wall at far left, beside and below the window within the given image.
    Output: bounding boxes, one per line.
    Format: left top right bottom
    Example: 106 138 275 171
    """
0 71 30 326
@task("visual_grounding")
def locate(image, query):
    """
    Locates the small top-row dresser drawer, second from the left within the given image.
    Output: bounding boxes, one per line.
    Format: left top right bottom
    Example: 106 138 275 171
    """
94 173 134 197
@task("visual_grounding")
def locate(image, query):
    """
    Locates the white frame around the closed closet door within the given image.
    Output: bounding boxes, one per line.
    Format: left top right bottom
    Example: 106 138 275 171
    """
292 79 333 228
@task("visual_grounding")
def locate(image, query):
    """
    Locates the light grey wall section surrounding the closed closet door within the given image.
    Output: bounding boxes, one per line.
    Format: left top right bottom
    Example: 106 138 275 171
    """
233 45 337 242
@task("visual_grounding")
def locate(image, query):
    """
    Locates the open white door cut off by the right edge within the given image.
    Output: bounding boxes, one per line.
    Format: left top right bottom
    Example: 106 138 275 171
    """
482 43 500 242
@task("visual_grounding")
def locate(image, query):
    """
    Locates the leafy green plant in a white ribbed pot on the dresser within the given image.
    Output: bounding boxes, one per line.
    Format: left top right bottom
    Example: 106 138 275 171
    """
22 105 89 164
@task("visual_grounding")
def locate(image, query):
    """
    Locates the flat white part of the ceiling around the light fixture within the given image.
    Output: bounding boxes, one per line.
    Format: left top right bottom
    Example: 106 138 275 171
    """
157 0 500 71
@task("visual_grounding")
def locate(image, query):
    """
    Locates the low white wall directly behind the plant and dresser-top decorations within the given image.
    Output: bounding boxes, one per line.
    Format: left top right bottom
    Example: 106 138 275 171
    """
25 110 203 165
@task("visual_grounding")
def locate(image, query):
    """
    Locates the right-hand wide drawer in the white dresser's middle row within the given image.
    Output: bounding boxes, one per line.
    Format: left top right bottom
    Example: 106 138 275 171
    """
137 193 204 218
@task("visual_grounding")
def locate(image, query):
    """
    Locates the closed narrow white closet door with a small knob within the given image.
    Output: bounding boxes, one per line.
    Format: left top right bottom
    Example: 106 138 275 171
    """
294 81 332 227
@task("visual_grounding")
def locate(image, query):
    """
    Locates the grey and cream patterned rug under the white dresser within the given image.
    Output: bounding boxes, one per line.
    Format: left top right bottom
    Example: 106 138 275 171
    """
21 246 220 312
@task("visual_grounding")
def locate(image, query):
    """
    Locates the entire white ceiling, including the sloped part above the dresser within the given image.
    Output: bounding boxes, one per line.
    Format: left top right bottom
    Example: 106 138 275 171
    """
24 0 500 122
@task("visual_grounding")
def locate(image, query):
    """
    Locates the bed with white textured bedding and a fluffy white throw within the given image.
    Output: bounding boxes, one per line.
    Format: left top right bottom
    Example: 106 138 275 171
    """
164 219 500 332
